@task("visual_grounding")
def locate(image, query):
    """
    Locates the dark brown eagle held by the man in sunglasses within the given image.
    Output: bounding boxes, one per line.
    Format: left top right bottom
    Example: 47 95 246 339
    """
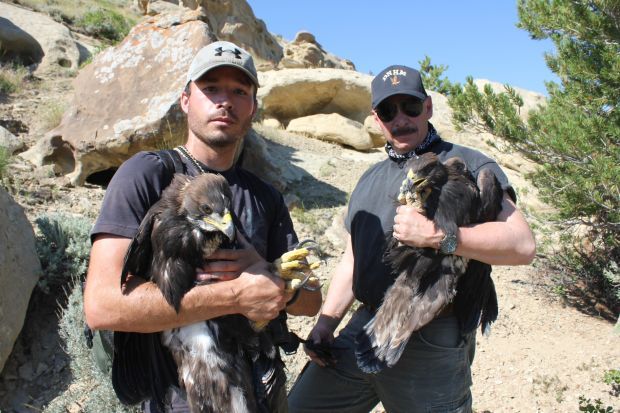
356 153 503 373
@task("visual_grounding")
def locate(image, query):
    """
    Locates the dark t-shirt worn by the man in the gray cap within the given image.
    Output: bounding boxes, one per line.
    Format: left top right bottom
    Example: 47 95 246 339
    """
91 152 297 262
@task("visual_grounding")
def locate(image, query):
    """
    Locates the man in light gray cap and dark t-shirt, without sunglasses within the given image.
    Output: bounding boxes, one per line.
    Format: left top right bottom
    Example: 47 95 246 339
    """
84 41 321 412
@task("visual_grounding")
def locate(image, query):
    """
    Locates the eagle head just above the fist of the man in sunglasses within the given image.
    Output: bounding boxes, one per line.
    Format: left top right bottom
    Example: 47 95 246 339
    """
398 152 448 211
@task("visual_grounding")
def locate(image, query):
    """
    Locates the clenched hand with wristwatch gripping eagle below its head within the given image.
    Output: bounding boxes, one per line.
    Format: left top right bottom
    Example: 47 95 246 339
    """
393 205 445 249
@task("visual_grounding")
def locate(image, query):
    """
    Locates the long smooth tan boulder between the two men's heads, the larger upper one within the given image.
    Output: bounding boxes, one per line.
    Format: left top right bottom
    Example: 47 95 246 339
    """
258 69 372 124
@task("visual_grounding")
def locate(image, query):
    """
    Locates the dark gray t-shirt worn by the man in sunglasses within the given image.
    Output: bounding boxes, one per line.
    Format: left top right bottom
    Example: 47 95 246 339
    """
345 140 516 307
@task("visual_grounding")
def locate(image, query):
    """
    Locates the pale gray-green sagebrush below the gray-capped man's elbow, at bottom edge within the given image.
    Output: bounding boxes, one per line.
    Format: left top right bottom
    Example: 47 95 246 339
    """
44 278 139 413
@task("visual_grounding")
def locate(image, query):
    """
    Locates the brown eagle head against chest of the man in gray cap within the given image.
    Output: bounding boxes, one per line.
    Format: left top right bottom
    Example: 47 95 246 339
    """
180 174 235 242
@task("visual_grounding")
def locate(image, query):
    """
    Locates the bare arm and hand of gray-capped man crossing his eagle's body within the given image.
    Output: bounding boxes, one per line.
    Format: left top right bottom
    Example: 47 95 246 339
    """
84 236 286 332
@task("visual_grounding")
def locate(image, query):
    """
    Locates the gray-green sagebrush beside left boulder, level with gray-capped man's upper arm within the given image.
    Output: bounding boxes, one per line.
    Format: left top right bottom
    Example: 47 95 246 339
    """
35 214 92 292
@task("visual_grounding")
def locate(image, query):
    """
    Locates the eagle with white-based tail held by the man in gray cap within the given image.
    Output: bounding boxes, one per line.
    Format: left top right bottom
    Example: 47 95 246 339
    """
112 173 285 413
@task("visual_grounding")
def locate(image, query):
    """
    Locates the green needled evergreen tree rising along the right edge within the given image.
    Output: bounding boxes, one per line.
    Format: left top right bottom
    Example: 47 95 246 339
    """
449 0 620 305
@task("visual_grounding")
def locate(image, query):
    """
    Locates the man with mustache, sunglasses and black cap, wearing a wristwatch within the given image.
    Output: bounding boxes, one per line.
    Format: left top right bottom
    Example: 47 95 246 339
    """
289 66 535 413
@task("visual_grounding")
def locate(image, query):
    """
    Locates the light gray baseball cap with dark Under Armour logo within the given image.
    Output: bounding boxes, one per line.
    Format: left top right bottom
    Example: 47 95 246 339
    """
187 41 258 88
